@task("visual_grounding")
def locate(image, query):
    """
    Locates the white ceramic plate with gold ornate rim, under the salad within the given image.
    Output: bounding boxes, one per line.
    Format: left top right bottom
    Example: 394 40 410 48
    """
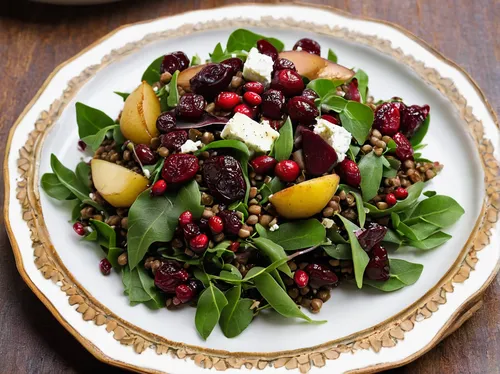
5 5 500 373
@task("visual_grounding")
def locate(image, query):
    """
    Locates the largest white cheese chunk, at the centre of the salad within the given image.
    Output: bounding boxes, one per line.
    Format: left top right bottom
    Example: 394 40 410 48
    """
221 113 280 152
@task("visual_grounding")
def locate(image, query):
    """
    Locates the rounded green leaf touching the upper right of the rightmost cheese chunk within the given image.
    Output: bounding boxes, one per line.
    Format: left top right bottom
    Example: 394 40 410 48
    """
340 101 373 144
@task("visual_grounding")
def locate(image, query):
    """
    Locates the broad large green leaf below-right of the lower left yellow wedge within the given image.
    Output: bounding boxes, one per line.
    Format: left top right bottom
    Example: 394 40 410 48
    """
127 180 204 269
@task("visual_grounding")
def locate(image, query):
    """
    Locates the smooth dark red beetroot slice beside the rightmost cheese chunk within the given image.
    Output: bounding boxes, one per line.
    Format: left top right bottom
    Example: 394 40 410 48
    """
302 129 337 175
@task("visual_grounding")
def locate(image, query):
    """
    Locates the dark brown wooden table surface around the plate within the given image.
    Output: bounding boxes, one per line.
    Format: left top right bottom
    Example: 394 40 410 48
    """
0 0 500 374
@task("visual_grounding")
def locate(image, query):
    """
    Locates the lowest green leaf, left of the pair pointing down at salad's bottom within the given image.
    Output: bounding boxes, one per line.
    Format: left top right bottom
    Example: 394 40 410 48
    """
194 283 227 340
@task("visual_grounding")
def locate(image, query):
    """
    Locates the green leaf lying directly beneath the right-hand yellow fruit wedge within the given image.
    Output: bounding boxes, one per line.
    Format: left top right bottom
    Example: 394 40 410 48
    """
256 218 326 251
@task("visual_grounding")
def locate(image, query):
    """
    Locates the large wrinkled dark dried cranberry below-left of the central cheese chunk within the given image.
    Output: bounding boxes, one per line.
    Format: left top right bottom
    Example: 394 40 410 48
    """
203 156 246 204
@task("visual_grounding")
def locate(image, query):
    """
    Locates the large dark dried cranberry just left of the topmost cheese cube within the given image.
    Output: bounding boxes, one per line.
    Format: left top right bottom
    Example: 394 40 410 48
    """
189 64 235 100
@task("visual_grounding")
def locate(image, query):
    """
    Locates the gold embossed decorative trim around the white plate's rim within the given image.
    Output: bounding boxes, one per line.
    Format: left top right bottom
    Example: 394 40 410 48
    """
4 3 500 372
